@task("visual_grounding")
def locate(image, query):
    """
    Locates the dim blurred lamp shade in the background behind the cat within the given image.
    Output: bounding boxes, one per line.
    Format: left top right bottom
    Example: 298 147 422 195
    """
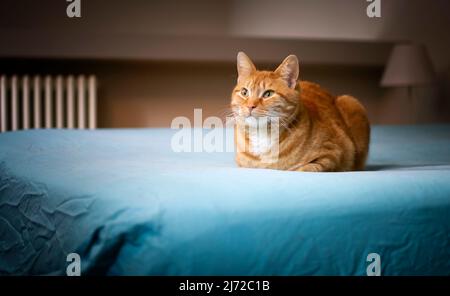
381 44 435 86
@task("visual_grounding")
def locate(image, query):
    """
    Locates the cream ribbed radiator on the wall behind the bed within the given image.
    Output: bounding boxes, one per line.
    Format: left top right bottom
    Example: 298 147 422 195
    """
0 75 97 132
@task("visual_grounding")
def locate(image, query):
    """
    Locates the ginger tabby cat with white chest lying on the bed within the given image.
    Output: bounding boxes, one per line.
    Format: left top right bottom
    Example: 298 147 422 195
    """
231 52 370 172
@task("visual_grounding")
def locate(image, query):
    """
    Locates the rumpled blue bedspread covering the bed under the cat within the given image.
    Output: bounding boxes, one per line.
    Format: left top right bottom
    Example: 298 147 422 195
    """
0 126 450 275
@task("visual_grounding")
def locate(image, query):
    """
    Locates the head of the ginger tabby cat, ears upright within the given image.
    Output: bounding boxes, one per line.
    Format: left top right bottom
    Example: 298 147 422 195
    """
231 52 300 122
